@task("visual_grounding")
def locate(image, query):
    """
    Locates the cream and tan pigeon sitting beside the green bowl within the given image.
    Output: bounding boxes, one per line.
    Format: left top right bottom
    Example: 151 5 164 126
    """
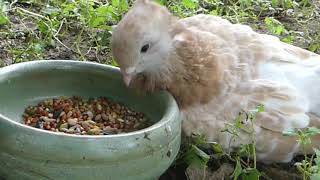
111 0 320 162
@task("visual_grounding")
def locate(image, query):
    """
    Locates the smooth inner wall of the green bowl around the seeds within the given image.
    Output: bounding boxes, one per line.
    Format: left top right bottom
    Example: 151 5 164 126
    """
0 60 168 126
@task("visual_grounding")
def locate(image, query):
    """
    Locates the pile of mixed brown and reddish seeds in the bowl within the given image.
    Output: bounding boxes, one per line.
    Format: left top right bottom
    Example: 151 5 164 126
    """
23 96 150 135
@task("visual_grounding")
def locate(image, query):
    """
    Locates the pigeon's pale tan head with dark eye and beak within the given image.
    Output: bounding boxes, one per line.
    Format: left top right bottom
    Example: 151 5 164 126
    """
111 0 179 86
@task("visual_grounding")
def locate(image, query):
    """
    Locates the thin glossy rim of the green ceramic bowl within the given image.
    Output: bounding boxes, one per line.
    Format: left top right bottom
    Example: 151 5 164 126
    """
0 59 180 139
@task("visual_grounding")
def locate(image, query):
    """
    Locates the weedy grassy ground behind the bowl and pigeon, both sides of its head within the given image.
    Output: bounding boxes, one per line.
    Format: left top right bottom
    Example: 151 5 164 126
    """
0 0 320 64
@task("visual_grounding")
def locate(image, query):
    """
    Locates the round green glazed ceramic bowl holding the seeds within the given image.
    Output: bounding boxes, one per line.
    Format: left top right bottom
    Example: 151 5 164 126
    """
0 60 181 180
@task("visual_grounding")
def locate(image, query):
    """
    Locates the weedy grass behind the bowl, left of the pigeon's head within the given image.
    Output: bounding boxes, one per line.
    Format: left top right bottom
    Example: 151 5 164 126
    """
0 0 131 63
